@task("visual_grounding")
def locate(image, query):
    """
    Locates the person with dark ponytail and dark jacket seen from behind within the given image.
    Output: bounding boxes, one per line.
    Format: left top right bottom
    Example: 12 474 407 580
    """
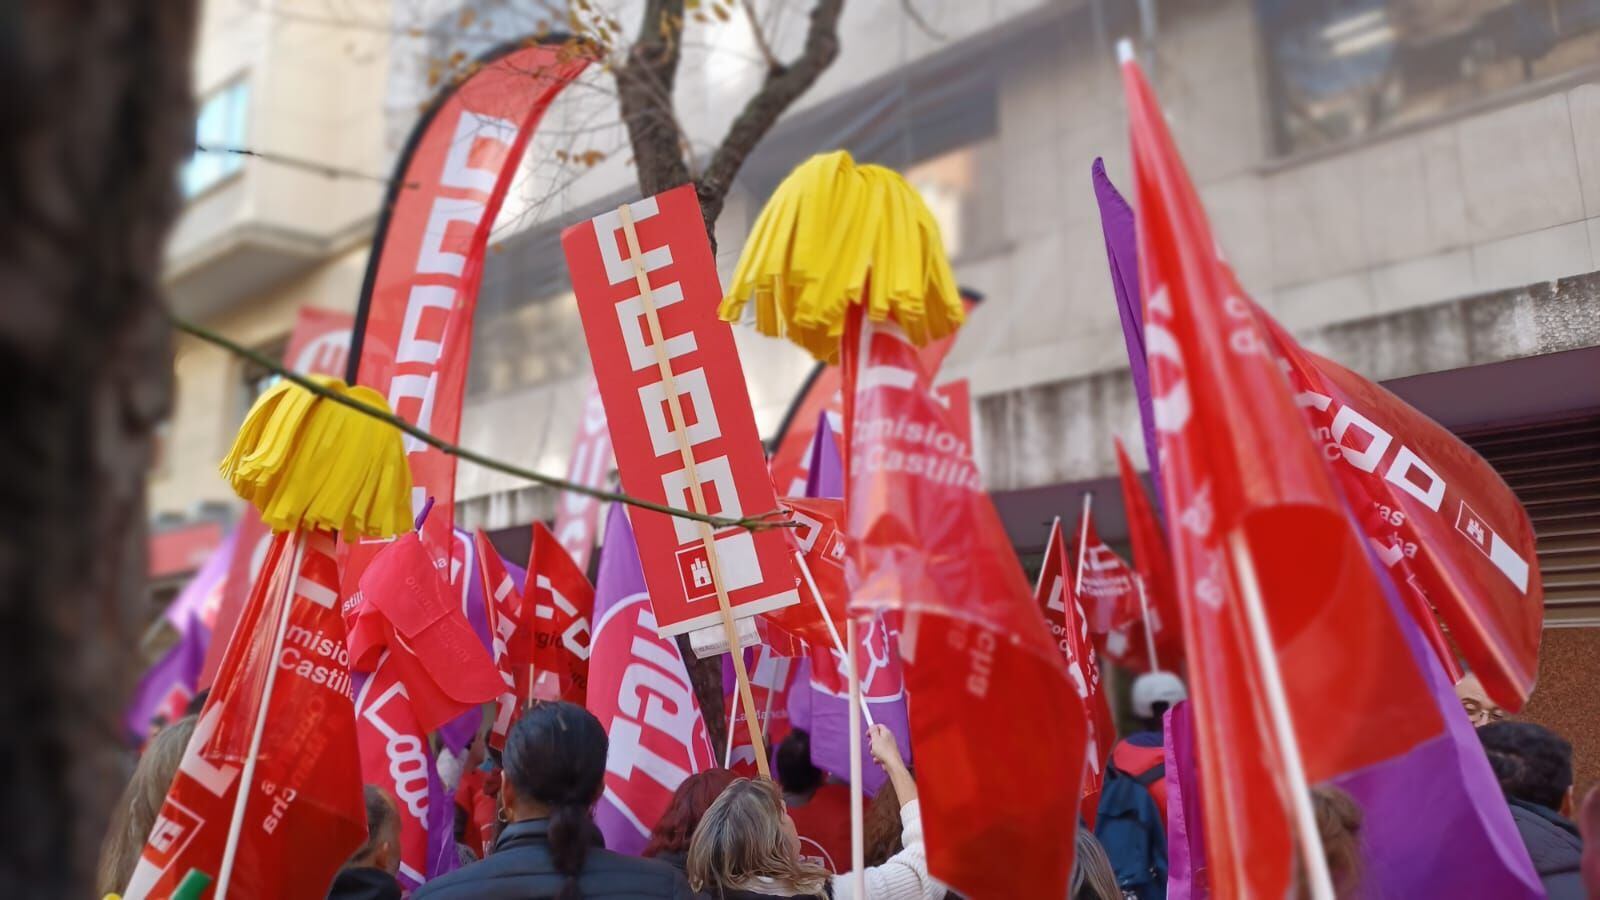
411 703 693 900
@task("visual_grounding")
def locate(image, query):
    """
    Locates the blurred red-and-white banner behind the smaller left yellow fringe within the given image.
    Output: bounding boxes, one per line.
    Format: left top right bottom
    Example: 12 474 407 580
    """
198 306 355 687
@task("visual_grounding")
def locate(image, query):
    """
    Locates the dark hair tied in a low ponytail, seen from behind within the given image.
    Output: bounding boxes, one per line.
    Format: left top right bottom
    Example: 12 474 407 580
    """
502 701 606 900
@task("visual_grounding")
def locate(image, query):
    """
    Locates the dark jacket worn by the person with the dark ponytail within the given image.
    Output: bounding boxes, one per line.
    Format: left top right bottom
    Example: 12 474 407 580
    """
411 818 693 900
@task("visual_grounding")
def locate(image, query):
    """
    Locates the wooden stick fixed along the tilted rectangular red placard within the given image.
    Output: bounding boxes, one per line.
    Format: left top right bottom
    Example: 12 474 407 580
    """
618 203 773 778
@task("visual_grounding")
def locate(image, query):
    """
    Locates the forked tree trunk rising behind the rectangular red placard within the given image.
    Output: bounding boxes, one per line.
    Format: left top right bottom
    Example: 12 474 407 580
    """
616 0 845 757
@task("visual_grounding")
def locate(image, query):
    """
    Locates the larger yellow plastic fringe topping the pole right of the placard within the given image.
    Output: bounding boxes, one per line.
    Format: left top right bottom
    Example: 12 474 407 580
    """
718 151 965 362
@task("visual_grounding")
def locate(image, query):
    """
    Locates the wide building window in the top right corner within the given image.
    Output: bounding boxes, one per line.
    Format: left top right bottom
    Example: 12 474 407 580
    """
1256 0 1600 154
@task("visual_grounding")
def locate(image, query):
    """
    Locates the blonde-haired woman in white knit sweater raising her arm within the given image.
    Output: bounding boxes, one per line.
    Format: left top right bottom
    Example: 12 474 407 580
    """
688 725 944 900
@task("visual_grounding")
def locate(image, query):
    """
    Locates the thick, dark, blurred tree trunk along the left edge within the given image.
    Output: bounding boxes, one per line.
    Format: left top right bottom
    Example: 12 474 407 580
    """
0 0 195 897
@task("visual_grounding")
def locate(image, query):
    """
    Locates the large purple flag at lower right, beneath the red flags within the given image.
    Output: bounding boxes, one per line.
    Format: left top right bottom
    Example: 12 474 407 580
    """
1334 541 1544 900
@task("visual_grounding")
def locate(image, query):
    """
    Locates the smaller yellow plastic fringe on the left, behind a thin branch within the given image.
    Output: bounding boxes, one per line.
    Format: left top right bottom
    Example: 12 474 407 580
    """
221 375 411 540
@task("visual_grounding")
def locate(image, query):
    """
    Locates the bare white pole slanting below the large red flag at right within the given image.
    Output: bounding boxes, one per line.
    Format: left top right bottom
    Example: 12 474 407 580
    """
1227 530 1334 900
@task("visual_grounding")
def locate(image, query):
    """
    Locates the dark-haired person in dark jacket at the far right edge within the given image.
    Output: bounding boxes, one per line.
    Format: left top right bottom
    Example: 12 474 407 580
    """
1478 722 1586 900
